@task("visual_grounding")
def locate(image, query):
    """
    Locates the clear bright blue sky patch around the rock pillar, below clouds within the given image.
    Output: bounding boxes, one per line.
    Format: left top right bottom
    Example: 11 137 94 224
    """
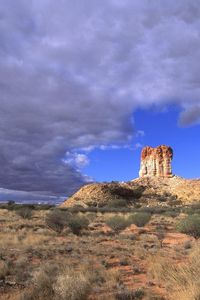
83 107 200 181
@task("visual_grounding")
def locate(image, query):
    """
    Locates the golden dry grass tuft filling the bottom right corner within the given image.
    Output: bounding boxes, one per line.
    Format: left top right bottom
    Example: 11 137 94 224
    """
149 243 200 300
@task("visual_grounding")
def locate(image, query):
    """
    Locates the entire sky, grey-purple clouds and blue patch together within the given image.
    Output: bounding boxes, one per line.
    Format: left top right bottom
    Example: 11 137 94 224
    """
0 0 200 201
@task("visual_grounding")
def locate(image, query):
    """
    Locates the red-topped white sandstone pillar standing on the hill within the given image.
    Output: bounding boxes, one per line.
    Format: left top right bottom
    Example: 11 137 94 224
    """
139 145 173 177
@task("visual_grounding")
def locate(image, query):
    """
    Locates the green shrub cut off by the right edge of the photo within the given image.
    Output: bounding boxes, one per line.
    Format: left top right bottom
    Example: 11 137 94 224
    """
176 215 200 238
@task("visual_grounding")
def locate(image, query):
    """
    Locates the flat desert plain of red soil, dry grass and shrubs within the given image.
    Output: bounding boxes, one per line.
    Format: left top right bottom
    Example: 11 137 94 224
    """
0 203 200 300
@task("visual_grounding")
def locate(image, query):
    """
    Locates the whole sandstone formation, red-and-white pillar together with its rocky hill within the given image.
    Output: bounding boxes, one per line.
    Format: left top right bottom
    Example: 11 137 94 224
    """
61 145 200 208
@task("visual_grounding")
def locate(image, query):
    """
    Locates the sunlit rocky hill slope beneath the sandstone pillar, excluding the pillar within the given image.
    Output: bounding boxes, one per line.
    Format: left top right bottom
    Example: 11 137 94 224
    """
61 176 200 207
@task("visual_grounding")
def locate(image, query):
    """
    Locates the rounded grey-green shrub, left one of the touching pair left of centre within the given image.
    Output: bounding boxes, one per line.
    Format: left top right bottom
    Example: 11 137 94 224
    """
45 209 71 233
